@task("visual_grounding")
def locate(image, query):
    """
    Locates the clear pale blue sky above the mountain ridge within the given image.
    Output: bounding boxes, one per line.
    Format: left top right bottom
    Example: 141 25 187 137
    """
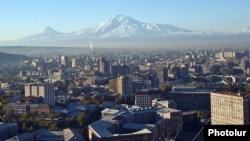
0 0 250 41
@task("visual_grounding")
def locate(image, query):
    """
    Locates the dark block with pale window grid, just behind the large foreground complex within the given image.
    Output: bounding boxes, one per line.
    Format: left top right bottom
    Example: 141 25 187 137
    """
135 88 161 108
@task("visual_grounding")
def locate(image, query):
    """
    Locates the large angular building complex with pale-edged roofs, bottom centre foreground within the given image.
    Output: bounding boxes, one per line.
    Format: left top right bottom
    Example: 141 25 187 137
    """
88 106 183 141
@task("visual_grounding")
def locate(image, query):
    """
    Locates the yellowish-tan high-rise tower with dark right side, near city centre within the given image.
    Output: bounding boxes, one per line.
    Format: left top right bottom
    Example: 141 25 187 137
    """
117 75 132 95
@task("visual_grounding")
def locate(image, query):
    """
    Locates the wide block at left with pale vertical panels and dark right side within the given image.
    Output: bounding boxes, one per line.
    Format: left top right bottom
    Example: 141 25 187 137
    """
24 83 55 106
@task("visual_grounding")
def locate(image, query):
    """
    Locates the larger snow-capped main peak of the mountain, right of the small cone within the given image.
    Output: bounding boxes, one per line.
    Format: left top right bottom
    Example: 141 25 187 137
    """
71 15 191 39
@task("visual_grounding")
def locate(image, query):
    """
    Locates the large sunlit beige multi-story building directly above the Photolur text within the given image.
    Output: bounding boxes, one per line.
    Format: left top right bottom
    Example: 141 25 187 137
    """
211 92 250 125
